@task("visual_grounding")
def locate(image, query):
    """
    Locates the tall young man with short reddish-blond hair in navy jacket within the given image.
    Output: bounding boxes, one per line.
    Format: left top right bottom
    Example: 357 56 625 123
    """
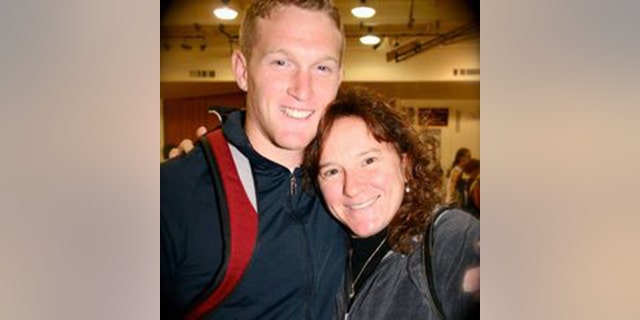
160 0 346 319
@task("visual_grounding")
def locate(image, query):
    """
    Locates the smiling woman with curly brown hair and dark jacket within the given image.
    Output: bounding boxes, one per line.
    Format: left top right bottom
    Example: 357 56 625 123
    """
304 88 480 320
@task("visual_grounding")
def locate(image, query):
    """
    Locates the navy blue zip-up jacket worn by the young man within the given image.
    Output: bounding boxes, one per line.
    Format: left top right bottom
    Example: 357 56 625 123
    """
160 112 347 319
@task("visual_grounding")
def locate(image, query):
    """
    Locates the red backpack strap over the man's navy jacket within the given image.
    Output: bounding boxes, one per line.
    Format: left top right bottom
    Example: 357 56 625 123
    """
187 130 258 319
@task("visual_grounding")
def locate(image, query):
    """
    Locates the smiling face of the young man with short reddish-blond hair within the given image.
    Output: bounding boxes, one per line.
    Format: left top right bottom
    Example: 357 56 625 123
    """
233 6 343 157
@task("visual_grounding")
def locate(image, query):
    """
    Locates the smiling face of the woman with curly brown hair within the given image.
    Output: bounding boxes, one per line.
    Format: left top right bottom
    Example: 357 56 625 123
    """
318 117 406 238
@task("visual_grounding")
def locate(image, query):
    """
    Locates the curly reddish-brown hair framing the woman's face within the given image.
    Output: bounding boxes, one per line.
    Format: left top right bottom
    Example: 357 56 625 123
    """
302 87 442 254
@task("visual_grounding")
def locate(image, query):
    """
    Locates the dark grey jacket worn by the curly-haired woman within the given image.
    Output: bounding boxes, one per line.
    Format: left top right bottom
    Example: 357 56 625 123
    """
335 209 480 320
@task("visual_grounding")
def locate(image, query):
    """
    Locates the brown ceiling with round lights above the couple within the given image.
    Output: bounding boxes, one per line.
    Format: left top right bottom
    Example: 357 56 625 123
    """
160 0 479 50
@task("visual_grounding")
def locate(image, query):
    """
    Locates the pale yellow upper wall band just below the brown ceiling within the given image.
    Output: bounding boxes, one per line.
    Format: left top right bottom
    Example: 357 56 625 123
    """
160 39 480 82
